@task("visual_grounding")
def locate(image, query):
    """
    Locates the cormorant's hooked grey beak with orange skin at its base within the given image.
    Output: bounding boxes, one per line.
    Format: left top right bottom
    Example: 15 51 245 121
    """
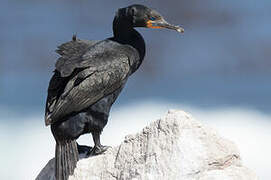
147 19 184 33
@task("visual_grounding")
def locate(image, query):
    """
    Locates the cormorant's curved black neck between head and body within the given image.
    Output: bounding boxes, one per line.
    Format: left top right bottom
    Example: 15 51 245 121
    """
113 17 145 64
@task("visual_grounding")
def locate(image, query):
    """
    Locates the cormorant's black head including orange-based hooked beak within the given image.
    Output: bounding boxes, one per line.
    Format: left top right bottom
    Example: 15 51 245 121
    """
117 4 184 33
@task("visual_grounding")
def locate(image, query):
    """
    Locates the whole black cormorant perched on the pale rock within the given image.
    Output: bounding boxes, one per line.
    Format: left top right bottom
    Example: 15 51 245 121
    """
45 5 184 180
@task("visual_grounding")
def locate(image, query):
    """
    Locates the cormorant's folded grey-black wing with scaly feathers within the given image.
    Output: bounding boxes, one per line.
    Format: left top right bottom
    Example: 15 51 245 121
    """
45 40 139 125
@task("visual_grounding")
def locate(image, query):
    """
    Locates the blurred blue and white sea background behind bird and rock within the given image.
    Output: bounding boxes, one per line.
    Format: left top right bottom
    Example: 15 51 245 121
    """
0 0 271 180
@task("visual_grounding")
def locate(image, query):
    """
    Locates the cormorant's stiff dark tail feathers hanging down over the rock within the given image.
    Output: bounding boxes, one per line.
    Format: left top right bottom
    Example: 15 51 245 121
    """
55 140 79 180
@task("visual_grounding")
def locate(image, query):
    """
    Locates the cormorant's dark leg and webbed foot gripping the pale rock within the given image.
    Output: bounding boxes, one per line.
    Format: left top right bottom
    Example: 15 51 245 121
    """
87 131 109 156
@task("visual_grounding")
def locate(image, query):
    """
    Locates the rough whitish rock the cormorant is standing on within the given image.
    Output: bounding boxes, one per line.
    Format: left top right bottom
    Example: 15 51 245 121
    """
37 110 257 180
